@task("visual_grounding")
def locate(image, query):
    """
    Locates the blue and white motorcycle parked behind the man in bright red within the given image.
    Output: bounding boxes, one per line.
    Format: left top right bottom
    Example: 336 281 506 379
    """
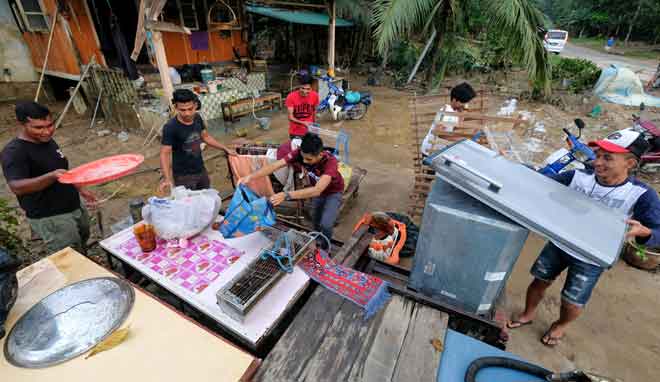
316 75 371 121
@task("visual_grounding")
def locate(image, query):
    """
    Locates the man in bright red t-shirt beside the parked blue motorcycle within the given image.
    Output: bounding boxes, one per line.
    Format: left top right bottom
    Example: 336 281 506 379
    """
285 76 319 139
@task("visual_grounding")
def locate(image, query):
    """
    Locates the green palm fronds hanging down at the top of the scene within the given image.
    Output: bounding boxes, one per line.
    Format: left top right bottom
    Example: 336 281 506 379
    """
372 0 550 93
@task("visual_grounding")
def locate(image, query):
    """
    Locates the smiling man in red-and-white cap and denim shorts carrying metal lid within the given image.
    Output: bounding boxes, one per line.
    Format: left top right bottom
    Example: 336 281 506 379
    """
507 129 660 347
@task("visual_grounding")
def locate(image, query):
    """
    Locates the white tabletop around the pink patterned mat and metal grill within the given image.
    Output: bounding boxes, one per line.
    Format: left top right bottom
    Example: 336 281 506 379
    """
100 227 309 352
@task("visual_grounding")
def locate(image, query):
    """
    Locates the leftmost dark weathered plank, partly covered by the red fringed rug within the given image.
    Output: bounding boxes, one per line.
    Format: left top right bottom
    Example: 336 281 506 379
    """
255 231 373 381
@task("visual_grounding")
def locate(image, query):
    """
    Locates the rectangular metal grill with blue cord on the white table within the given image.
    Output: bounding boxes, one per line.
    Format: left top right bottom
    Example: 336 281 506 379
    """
216 228 316 321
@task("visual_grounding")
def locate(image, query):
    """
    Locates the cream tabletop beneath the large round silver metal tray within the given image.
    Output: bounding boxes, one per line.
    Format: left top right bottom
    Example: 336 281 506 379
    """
0 249 259 382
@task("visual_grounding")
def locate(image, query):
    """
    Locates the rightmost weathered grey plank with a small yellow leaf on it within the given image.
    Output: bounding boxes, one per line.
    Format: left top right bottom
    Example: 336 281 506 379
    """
392 304 449 382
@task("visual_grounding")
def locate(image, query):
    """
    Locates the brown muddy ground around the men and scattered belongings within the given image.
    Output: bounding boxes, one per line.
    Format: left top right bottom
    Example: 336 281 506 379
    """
0 72 660 381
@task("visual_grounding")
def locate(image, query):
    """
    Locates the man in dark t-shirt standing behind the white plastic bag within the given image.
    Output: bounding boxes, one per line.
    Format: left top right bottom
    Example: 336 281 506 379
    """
160 89 236 192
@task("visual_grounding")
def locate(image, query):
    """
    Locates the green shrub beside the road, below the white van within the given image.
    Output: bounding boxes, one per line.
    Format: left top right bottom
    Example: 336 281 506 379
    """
550 56 601 93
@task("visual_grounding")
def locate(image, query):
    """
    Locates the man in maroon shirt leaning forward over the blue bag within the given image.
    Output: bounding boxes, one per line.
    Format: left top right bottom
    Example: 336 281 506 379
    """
238 133 344 249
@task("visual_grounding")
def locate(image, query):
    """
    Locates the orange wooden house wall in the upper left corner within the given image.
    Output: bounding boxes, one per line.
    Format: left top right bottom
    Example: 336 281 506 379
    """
23 0 106 76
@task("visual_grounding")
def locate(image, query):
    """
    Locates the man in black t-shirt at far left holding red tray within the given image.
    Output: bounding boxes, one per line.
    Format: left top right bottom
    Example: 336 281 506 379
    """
0 102 90 253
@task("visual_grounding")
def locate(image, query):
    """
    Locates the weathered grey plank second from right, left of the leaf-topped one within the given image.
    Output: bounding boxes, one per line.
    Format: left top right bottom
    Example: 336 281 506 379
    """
347 296 415 382
